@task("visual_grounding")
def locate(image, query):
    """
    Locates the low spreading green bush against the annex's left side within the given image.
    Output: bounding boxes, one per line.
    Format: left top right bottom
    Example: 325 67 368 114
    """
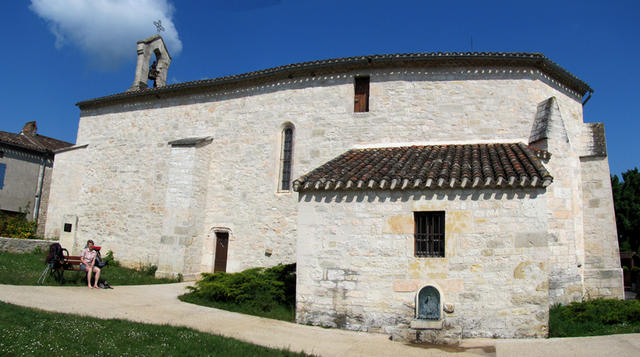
189 264 296 311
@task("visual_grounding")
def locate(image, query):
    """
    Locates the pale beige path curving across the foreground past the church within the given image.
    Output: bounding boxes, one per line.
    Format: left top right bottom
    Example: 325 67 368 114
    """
0 283 640 357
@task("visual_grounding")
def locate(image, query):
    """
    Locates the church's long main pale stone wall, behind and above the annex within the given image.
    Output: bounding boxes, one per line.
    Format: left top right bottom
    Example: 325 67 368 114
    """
47 64 582 271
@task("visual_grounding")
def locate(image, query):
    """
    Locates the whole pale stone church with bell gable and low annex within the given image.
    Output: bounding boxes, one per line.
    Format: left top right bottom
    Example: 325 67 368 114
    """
46 36 623 341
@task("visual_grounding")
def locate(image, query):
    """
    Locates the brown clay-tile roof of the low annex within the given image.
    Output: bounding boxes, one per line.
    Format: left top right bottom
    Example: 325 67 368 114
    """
293 143 553 192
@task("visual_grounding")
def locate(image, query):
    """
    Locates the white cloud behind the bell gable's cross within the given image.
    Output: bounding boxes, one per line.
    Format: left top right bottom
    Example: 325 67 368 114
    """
29 0 182 68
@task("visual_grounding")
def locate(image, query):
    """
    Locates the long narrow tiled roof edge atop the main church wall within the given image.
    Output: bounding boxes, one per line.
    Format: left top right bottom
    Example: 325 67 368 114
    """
76 52 593 109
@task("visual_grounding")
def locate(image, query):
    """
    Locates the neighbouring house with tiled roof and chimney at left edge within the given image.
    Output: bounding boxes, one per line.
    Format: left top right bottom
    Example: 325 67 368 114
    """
0 121 73 236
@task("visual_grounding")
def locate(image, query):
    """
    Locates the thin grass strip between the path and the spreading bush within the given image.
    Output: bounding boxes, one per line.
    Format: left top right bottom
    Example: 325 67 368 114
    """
178 293 296 322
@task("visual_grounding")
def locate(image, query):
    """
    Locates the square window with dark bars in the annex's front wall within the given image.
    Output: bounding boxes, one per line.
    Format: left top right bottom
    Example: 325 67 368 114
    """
413 211 444 257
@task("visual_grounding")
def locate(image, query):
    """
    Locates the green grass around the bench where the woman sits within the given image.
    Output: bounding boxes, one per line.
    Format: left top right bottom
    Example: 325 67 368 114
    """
0 252 177 286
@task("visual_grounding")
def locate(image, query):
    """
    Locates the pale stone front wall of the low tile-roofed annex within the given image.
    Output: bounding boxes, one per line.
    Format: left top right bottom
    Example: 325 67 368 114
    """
296 190 550 338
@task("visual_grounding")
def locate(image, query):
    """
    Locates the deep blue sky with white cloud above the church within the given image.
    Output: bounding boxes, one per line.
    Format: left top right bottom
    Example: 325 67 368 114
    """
0 0 640 174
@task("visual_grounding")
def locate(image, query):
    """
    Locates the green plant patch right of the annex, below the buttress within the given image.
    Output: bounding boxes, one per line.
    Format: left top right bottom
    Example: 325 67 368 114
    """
549 299 640 337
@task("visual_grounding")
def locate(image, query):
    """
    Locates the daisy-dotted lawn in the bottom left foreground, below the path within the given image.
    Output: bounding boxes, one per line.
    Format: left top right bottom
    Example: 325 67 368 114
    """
0 302 306 357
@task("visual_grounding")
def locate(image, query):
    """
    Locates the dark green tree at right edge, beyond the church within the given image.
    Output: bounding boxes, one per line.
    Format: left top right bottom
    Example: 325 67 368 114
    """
611 167 640 252
